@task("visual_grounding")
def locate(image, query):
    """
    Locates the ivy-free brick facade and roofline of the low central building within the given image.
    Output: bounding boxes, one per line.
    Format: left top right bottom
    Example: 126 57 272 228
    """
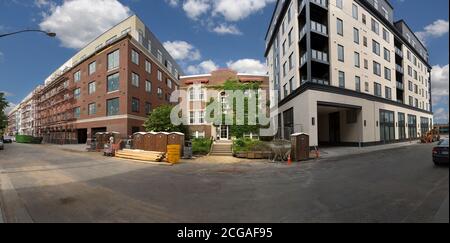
180 69 269 140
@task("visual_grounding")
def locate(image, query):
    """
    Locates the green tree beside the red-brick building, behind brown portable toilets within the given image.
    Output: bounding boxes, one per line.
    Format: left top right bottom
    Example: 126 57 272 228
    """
144 105 188 136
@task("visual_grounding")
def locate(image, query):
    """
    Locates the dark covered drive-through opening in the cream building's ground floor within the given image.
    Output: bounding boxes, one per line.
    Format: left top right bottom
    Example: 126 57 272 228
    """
317 102 363 146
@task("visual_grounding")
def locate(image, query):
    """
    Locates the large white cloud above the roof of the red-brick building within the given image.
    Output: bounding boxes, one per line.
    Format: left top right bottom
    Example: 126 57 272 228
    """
39 0 132 49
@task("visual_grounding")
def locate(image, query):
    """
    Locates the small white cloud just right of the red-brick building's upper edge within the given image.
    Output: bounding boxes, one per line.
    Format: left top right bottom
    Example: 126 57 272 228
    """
163 41 201 61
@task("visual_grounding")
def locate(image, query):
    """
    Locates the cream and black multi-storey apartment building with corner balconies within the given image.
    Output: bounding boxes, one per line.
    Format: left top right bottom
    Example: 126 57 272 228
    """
265 0 433 146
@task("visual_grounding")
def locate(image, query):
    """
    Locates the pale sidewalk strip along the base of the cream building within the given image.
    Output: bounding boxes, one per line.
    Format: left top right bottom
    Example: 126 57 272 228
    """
319 141 419 159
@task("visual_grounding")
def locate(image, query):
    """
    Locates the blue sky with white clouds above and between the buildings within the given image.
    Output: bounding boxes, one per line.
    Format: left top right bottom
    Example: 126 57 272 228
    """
0 0 449 123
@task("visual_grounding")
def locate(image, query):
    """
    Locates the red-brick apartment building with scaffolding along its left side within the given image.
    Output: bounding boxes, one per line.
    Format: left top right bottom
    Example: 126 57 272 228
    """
36 16 182 144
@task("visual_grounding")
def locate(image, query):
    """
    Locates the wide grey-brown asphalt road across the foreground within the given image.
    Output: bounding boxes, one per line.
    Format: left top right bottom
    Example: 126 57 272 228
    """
0 144 449 223
